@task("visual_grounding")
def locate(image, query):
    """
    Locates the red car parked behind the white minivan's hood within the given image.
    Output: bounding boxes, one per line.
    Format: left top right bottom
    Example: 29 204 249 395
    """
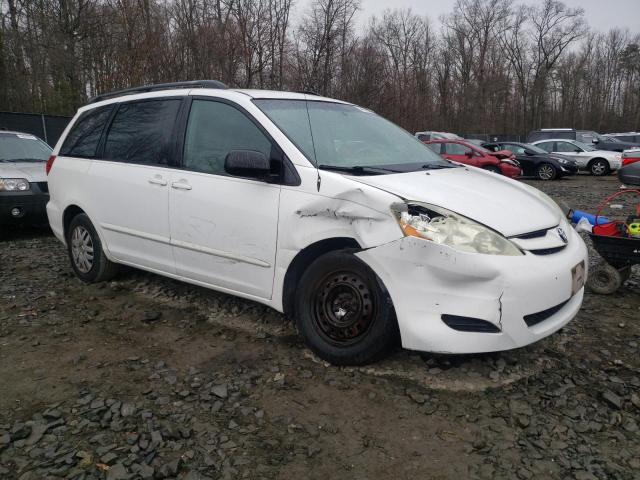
424 139 522 178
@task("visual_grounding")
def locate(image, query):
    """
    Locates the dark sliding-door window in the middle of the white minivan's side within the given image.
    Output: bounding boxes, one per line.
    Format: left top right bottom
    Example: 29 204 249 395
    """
103 98 182 165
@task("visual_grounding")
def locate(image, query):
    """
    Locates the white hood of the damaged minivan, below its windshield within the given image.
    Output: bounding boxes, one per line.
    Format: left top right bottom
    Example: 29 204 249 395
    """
353 168 560 237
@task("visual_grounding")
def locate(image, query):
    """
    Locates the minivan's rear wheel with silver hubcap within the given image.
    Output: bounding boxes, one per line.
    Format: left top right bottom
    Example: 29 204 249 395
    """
67 213 118 283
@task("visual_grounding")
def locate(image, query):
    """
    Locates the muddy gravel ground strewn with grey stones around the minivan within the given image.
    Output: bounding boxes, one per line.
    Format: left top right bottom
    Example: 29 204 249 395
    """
0 176 640 480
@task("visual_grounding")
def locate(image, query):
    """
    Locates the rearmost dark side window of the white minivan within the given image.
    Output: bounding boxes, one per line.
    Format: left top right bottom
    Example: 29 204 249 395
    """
60 105 113 158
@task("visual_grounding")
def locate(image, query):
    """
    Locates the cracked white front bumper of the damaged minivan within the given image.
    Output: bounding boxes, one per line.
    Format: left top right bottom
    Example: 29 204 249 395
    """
357 229 588 353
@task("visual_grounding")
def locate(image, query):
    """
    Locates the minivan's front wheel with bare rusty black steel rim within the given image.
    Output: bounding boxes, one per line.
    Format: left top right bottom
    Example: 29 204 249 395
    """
294 251 398 365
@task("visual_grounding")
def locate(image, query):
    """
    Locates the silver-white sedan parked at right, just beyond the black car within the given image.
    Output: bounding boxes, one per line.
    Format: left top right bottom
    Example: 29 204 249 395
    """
532 138 622 176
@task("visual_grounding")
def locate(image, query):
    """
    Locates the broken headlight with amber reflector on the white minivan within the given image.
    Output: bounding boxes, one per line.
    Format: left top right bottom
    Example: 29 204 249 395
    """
391 202 522 256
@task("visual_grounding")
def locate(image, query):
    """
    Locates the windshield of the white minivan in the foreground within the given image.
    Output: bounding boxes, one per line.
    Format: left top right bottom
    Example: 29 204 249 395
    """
254 99 452 172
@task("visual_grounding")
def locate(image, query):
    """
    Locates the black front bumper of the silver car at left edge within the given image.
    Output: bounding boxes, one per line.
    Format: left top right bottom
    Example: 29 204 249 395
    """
0 183 49 225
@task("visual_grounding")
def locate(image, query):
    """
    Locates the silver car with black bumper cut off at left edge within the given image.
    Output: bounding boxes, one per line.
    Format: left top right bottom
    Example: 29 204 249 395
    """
0 130 51 229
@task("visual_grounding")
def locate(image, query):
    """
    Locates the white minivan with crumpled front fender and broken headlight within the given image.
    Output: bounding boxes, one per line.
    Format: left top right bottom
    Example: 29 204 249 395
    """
47 81 587 364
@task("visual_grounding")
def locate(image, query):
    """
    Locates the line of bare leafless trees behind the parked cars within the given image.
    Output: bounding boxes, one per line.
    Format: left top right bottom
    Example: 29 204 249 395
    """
0 0 640 134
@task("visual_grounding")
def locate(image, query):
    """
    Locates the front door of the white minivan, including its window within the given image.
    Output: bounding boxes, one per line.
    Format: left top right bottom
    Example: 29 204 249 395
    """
169 99 280 299
